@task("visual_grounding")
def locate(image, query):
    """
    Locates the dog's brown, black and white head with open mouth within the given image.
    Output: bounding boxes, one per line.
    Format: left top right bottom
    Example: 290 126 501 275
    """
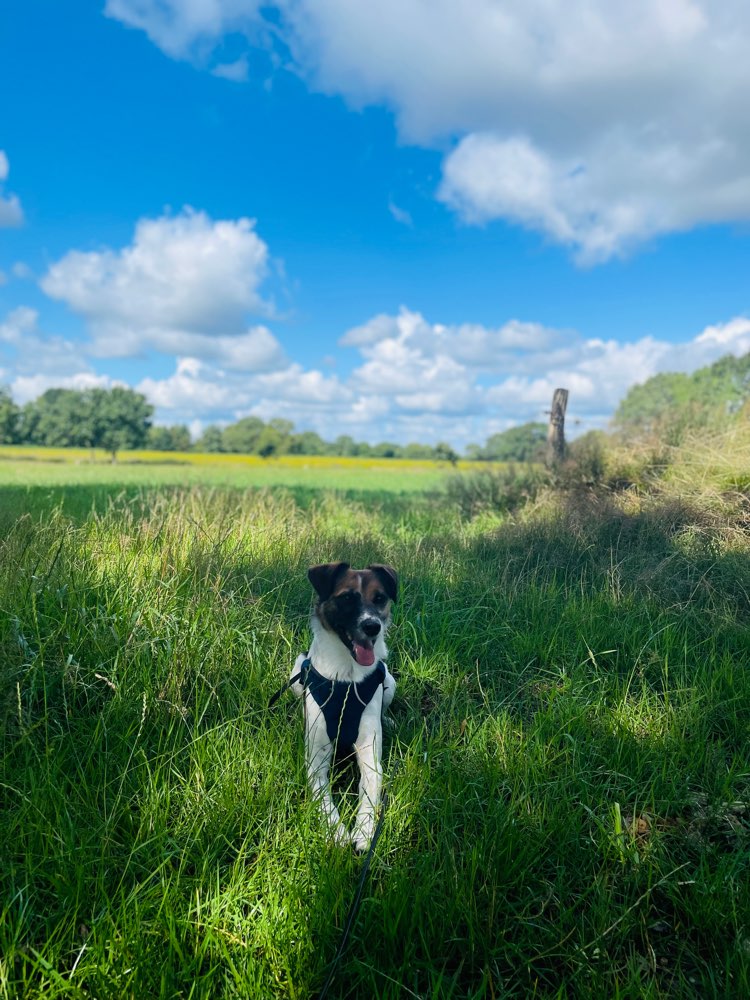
307 563 398 667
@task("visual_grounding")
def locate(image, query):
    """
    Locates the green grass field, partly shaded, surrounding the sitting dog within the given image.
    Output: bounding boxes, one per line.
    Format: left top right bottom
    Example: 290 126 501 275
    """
0 450 750 1000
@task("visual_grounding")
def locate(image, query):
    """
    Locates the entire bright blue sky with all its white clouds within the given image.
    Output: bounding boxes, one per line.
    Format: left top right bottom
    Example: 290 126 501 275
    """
0 0 750 446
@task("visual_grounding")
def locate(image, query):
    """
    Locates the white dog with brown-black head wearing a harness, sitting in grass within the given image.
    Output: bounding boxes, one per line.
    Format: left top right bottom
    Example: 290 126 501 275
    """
290 562 398 853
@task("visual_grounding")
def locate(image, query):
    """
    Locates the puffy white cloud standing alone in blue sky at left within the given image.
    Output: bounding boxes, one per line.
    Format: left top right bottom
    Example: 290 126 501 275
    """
40 209 284 371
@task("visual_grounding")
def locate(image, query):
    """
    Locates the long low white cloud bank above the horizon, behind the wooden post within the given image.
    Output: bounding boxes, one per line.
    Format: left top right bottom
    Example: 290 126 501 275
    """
128 309 750 445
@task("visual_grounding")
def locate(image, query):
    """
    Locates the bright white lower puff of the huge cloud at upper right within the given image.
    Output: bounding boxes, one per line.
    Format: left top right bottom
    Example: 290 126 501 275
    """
439 133 750 264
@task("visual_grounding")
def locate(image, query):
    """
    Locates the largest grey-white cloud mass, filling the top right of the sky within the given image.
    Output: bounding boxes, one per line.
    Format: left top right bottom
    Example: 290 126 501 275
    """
107 0 750 263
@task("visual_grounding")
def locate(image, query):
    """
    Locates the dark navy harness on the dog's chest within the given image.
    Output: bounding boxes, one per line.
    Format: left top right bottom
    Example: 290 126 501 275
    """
268 657 385 753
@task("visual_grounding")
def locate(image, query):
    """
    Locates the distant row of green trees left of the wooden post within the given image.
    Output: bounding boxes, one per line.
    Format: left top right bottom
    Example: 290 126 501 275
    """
0 386 546 463
